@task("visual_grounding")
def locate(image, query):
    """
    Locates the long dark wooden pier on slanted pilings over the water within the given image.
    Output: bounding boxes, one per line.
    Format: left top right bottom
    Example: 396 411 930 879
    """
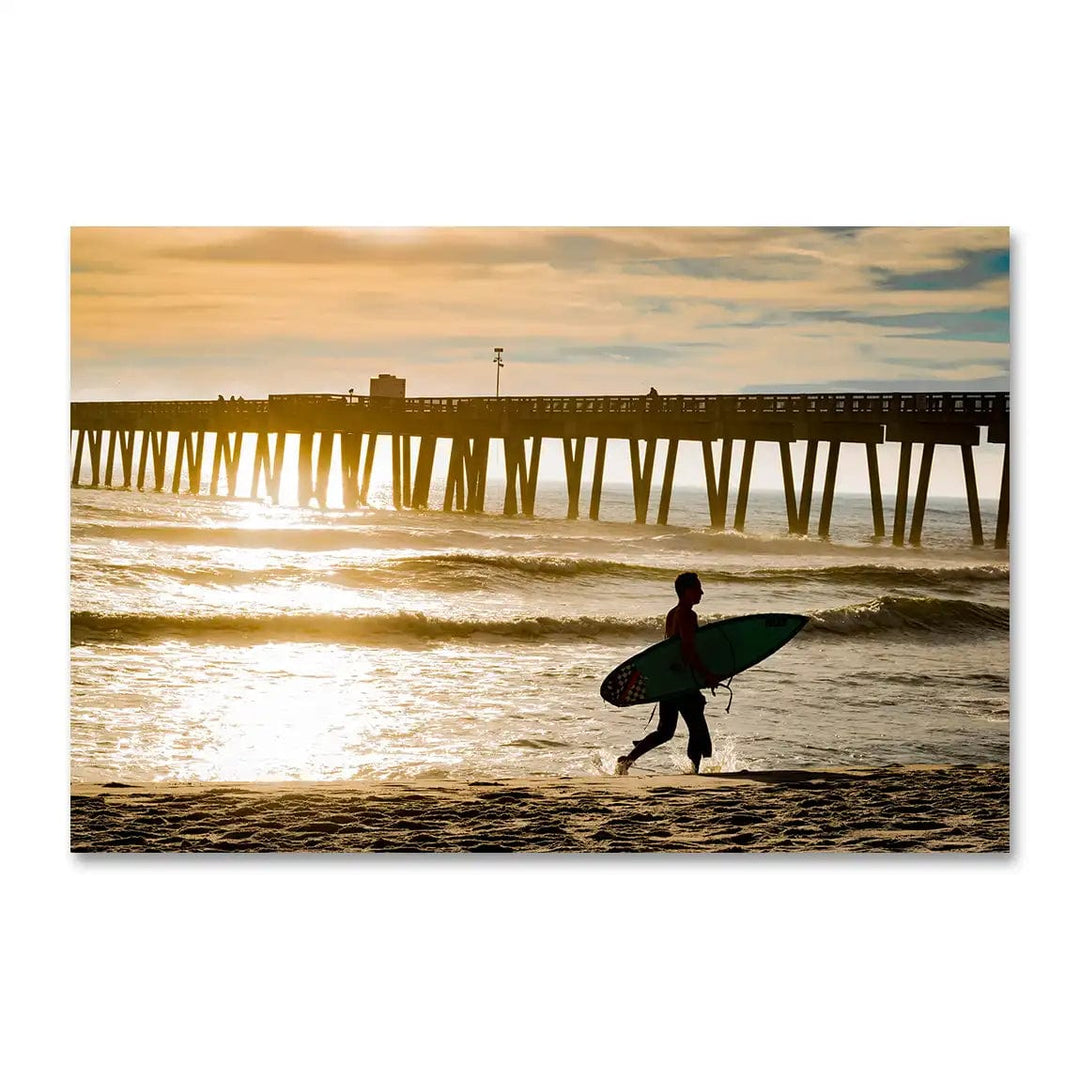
71 393 1009 548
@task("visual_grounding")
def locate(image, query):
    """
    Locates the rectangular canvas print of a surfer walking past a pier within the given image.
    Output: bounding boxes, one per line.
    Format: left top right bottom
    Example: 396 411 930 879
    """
69 226 1010 855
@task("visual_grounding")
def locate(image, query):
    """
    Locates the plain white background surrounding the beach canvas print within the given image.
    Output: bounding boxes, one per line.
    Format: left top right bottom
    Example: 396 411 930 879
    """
6 0 1078 1077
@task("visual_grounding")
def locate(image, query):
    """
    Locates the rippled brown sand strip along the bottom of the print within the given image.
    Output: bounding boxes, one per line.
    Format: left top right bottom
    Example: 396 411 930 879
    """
71 765 1009 852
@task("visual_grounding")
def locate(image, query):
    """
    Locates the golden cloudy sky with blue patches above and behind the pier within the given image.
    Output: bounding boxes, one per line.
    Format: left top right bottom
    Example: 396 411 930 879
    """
70 226 1010 497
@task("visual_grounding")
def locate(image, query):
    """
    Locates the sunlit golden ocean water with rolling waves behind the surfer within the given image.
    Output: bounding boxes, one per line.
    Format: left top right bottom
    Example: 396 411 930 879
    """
70 482 1010 783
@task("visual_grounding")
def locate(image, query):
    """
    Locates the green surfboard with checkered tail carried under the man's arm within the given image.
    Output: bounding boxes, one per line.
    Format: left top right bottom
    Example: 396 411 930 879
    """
600 612 810 707
